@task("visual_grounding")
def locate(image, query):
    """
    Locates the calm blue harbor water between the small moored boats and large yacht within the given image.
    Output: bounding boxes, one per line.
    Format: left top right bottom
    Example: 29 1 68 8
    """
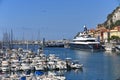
6 46 120 80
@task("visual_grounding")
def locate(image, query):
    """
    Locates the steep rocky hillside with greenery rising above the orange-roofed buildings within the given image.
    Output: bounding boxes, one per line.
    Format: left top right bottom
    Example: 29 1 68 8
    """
98 6 120 29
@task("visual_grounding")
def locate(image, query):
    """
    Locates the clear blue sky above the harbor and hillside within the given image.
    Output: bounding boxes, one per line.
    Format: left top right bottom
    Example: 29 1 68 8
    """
0 0 120 40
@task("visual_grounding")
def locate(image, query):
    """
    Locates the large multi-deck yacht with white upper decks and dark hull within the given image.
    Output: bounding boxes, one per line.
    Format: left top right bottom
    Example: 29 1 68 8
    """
69 26 104 51
